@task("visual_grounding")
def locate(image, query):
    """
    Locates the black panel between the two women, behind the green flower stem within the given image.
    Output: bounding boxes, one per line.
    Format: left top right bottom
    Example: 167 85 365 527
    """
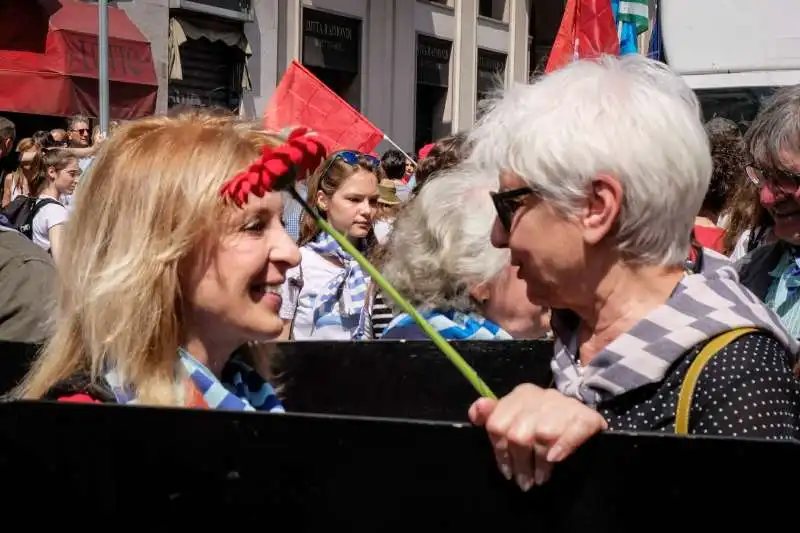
278 341 553 421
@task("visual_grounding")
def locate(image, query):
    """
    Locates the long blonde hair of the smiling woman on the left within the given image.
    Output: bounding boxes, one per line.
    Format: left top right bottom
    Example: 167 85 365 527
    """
11 111 283 405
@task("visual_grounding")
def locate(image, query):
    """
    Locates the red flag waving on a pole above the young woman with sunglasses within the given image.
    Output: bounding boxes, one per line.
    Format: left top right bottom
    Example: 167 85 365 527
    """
264 61 383 154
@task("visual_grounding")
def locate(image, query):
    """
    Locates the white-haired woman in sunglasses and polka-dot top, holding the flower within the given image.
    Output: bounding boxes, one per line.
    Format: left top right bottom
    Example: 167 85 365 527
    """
462 56 800 490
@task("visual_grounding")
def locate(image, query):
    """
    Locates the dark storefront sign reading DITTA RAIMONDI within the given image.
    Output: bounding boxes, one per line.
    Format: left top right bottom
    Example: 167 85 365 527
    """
303 8 361 73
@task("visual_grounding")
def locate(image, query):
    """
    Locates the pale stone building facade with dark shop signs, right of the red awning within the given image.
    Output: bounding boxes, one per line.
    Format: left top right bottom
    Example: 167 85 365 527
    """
116 0 564 151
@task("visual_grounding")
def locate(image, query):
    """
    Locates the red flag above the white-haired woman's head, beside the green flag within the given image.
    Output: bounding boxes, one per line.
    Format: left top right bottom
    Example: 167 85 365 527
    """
545 0 619 72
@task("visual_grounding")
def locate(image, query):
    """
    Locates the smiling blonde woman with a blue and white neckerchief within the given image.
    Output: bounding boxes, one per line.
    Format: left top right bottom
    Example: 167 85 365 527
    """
12 113 300 411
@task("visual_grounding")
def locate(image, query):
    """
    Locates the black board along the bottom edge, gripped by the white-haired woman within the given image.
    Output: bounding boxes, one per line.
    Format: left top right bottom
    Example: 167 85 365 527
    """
0 396 800 533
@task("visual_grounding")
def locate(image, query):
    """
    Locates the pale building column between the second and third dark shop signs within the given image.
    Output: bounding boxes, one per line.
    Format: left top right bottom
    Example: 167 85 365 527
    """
451 0 478 132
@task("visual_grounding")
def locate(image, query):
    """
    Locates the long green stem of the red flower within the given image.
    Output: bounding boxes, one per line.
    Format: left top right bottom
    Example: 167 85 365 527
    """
289 187 497 399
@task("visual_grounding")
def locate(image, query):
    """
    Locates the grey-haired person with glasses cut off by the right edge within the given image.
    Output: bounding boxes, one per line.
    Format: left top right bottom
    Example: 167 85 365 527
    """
739 85 800 338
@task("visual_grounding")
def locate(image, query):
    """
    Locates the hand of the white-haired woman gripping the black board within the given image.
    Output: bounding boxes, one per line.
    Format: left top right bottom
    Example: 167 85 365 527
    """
469 384 608 491
